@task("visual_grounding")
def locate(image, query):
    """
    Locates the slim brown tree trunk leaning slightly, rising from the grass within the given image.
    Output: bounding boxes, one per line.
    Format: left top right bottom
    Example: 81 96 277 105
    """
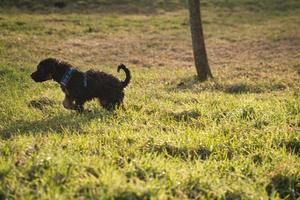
188 0 213 81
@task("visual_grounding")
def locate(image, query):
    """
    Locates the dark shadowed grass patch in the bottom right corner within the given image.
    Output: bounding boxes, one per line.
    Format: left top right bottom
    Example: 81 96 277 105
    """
266 174 300 200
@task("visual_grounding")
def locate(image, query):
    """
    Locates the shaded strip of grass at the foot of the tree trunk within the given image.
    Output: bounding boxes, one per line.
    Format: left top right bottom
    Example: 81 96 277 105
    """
168 76 287 94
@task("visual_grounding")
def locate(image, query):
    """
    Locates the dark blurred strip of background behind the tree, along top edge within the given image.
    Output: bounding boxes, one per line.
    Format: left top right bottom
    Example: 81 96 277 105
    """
0 0 300 12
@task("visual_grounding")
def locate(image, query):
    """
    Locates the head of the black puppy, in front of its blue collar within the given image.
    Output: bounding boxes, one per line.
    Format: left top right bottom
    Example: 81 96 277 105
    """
31 58 58 82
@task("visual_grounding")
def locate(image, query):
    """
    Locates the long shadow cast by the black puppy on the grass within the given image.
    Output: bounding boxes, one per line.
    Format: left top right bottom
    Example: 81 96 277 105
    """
0 110 116 140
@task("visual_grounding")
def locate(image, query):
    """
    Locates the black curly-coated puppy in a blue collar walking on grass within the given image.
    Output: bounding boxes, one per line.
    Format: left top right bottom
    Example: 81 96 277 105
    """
31 58 131 112
